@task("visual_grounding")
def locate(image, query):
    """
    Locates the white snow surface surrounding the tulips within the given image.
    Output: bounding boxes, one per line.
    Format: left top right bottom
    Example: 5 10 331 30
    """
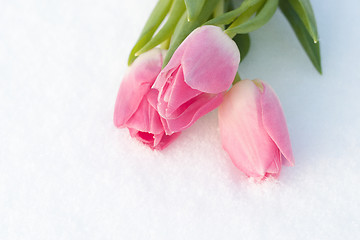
0 0 360 240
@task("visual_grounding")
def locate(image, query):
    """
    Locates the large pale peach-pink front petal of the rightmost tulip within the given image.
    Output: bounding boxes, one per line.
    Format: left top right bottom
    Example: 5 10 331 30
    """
219 80 280 179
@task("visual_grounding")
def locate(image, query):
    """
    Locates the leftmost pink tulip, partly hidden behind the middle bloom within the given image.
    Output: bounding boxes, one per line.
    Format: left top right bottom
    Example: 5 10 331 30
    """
114 49 179 150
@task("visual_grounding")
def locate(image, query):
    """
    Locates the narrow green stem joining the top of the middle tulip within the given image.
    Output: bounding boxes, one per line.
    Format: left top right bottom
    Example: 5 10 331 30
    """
205 0 264 25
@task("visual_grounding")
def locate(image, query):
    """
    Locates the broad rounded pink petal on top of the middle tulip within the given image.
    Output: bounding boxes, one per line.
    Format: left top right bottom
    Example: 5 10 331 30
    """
181 25 240 94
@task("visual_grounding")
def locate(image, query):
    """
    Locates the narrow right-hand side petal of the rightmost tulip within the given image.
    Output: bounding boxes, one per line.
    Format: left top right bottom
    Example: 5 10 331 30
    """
261 82 294 166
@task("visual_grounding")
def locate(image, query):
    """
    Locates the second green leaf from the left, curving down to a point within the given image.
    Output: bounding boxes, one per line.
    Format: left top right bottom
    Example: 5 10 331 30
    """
135 0 185 56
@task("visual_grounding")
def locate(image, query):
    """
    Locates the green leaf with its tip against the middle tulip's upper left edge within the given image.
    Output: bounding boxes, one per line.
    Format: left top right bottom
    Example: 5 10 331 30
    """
163 0 219 67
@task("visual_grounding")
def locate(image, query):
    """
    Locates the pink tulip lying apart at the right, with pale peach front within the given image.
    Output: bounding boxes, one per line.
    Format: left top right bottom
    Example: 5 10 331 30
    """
219 80 294 179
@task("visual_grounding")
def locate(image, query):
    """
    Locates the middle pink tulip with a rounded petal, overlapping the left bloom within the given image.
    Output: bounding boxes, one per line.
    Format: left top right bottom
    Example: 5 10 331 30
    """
153 26 240 134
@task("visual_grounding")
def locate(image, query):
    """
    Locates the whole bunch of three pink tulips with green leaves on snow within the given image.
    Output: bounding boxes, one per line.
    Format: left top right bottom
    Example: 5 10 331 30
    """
114 0 321 180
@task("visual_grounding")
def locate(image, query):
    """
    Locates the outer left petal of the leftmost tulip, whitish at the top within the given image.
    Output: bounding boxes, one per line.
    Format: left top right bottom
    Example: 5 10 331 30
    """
114 48 164 127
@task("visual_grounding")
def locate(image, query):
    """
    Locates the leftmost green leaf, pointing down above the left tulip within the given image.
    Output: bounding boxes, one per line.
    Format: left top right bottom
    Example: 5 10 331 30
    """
128 0 172 65
